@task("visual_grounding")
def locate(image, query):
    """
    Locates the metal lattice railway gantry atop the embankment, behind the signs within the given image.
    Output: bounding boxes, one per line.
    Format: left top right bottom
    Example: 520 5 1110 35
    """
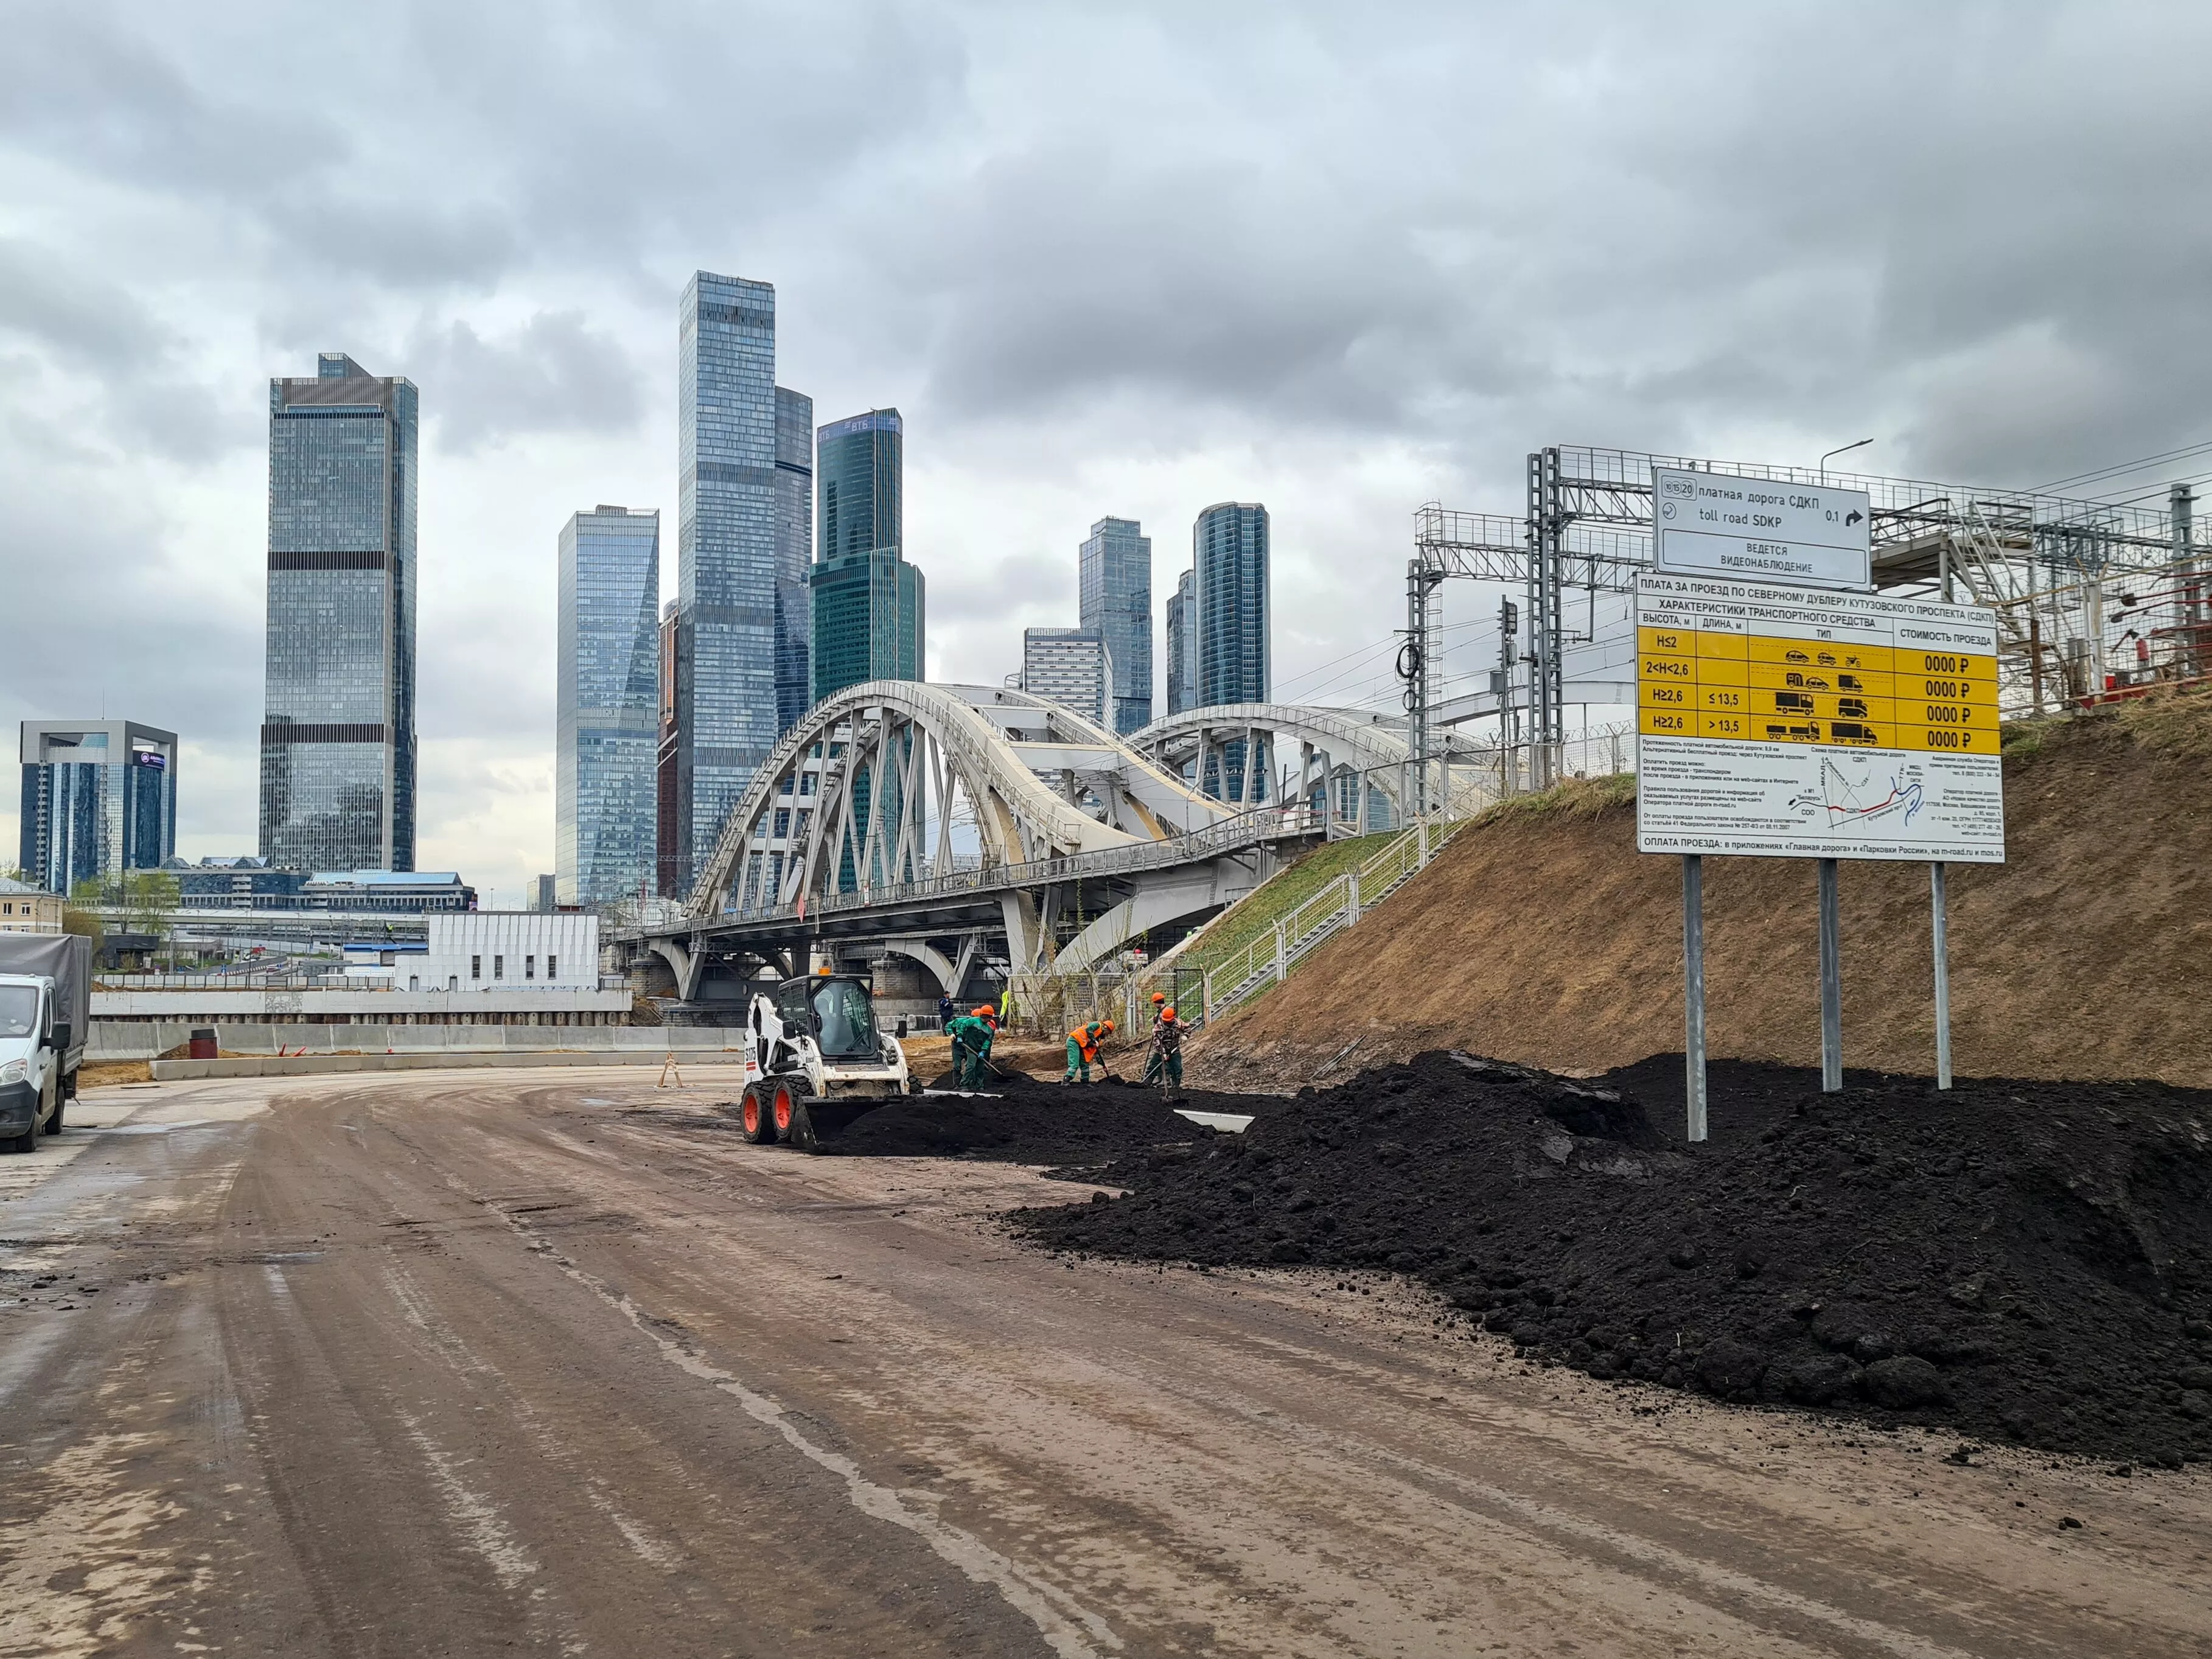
1407 445 2212 785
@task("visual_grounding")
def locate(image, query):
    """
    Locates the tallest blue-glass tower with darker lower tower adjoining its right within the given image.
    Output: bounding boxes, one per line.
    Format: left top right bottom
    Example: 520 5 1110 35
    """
672 270 814 887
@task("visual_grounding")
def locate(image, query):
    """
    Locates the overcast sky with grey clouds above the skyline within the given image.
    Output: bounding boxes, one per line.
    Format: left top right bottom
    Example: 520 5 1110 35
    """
0 0 2212 903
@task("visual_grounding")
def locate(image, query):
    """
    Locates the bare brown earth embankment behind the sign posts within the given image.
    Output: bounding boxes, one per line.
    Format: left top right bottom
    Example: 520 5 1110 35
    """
1190 697 2212 1088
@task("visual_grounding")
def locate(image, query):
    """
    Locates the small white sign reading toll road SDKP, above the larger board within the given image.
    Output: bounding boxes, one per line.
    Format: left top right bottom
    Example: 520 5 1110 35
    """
1652 467 1874 589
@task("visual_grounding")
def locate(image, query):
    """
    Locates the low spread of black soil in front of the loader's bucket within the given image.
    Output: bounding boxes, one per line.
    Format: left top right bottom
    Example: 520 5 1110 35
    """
829 1073 1283 1168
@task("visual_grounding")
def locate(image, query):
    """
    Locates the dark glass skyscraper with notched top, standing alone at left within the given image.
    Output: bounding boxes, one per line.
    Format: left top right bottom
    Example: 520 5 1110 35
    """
261 352 416 869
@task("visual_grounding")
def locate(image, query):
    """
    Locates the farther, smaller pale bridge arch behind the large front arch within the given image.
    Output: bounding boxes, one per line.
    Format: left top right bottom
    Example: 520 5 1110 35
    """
1126 704 1498 834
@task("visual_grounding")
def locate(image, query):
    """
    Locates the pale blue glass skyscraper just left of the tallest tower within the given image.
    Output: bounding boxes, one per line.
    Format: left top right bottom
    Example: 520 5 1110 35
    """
553 506 661 905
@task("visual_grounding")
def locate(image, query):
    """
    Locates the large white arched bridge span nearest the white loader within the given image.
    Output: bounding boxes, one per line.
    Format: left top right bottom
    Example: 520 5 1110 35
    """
628 681 1327 1002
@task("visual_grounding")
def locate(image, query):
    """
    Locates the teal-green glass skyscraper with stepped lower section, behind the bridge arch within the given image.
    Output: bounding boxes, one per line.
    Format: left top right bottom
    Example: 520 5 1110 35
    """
809 409 924 701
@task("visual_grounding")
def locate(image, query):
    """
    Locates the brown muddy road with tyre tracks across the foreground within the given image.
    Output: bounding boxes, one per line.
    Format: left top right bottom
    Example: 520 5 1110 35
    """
0 1070 2212 1659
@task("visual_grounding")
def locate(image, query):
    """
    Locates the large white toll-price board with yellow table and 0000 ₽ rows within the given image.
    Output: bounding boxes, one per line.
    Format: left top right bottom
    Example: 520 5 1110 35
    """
1637 573 2004 865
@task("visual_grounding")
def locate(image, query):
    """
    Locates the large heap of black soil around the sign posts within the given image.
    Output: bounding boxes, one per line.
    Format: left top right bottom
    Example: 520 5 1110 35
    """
1015 1053 2212 1467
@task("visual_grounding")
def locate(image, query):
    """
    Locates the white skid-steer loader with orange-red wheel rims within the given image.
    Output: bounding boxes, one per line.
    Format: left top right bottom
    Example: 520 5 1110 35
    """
736 973 923 1153
